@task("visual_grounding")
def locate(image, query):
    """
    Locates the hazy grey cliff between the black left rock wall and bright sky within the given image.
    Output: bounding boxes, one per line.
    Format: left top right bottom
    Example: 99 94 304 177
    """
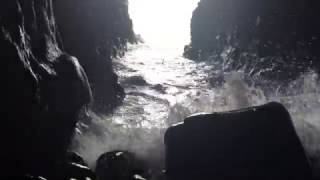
54 0 134 111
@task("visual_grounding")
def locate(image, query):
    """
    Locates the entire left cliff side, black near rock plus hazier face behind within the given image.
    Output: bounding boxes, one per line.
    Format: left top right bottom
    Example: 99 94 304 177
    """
0 0 134 179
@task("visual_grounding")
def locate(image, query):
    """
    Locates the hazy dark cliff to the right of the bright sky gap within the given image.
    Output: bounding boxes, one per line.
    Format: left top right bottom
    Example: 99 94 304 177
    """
185 0 320 64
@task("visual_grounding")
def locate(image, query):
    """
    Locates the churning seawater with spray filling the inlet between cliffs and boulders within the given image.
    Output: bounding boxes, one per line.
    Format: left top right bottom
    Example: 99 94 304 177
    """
74 45 320 176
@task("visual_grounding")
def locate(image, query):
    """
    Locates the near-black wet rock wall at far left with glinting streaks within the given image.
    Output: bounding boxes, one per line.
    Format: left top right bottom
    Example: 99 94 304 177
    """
0 0 91 177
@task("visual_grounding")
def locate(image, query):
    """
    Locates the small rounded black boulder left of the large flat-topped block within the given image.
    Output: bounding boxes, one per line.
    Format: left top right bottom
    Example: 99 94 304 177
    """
96 151 146 180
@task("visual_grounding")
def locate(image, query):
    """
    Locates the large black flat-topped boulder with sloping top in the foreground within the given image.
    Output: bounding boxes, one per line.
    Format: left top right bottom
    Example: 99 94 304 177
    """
165 103 312 180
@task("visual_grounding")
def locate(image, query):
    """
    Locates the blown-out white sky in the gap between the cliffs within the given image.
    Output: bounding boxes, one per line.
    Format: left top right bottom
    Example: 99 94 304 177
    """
129 0 199 48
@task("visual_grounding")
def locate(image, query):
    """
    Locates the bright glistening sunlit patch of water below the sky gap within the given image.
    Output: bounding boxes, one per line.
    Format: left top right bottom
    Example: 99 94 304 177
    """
113 44 208 128
